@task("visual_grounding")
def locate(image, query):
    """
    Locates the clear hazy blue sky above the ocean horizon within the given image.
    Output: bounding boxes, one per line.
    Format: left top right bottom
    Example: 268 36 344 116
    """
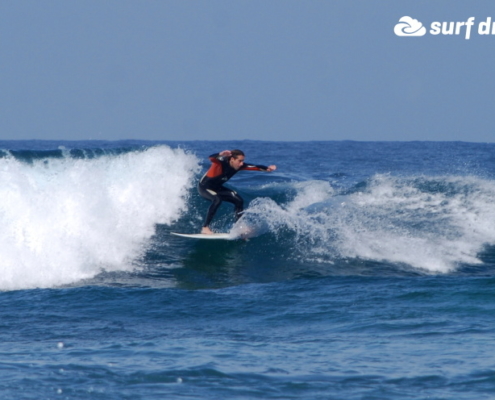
0 0 495 142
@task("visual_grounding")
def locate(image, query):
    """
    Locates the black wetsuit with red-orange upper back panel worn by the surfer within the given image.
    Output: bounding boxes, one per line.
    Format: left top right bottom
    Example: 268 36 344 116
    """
198 153 268 227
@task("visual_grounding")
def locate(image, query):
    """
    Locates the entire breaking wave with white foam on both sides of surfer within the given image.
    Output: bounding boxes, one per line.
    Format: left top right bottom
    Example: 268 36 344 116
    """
0 143 495 290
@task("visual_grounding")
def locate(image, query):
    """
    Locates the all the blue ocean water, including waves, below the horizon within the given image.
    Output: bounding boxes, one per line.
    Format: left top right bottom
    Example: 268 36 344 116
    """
0 141 495 399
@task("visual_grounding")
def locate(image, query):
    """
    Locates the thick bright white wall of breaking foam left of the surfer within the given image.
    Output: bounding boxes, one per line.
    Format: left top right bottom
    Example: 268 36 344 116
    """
0 145 198 290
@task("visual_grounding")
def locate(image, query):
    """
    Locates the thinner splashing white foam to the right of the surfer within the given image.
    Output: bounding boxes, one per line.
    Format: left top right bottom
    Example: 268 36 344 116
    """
242 175 495 272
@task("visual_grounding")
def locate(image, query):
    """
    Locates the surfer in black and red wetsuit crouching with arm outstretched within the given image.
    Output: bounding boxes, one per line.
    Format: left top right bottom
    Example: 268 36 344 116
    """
198 150 277 234
